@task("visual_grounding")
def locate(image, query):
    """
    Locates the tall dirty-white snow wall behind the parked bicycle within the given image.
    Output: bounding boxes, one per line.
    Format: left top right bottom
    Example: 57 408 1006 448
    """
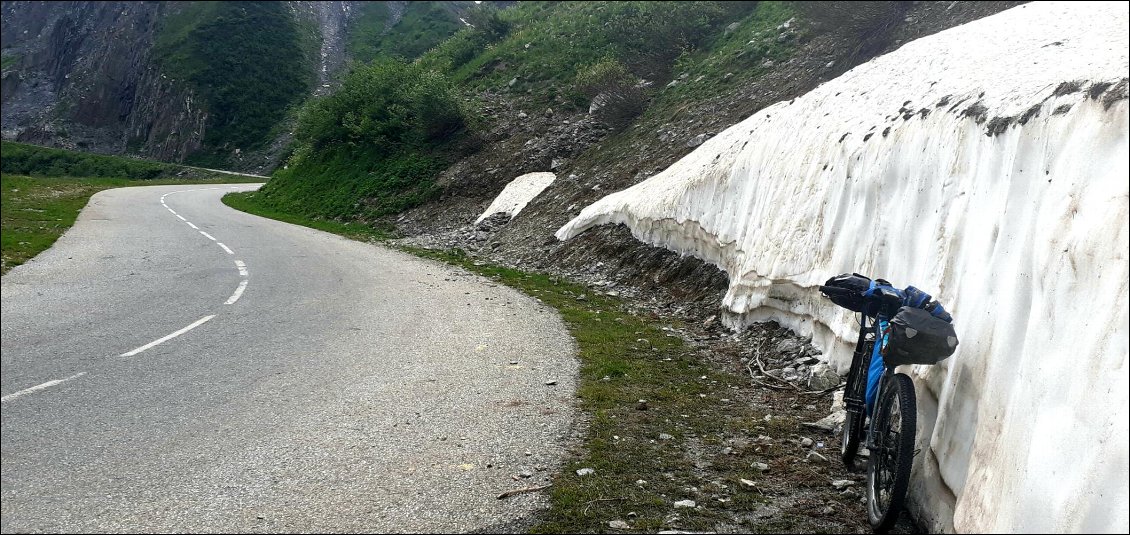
557 2 1130 533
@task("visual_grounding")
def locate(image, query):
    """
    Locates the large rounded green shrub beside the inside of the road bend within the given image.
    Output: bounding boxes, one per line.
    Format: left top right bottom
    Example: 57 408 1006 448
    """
257 60 467 219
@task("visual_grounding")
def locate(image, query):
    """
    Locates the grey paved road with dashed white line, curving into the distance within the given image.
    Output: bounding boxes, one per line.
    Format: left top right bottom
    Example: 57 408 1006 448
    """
0 184 576 533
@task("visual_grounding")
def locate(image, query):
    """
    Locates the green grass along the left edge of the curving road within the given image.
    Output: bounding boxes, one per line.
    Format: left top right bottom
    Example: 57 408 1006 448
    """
0 174 261 274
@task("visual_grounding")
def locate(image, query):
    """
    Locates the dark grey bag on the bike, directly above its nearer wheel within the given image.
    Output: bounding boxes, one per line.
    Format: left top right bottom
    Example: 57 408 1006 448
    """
883 307 957 365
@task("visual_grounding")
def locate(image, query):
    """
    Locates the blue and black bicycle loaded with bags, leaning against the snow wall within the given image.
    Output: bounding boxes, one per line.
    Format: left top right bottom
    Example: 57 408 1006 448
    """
820 274 957 533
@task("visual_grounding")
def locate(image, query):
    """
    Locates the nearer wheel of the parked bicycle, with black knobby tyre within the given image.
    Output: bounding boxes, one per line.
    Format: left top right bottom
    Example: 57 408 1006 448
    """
867 373 918 533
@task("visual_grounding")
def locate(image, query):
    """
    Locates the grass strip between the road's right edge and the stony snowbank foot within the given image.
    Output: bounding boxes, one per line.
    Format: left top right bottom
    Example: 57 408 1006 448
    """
224 193 849 533
